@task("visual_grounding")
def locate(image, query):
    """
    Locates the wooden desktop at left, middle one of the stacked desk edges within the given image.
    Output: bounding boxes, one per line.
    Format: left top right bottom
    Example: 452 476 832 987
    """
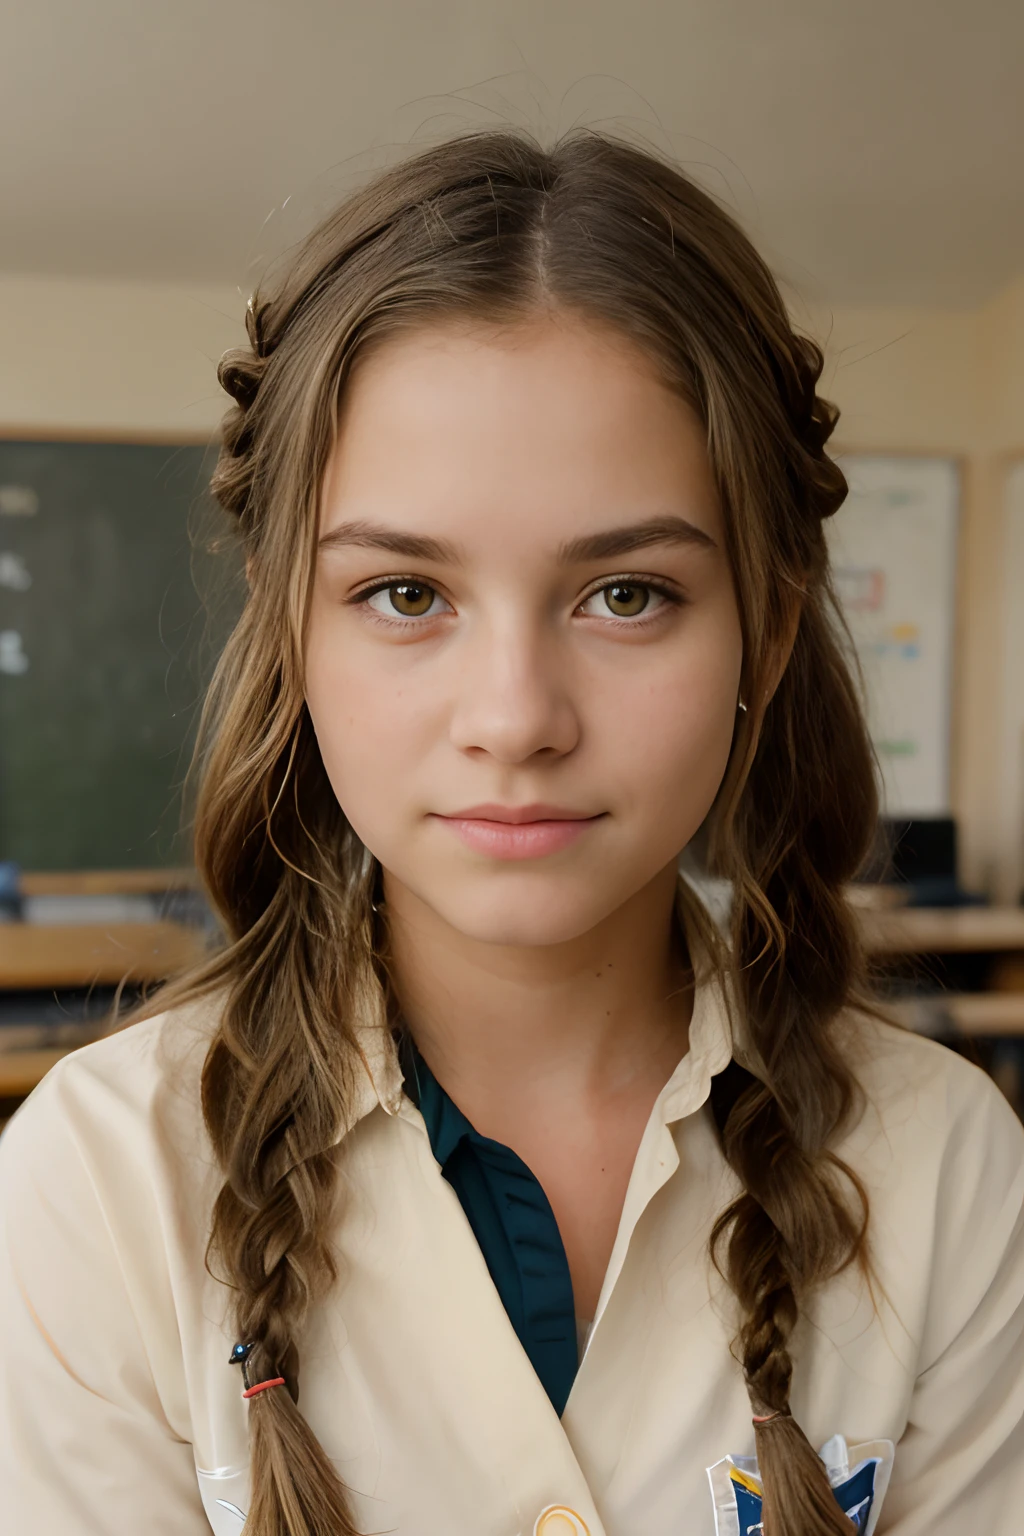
0 922 204 991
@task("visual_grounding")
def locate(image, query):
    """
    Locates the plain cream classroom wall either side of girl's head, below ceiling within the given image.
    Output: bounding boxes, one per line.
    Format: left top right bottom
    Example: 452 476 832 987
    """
0 275 1024 900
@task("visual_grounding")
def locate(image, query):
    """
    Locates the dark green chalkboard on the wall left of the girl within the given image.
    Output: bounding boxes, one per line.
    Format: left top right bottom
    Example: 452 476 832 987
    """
0 441 241 869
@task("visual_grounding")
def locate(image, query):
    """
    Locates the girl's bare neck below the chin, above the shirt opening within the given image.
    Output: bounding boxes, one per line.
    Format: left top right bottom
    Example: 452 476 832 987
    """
380 863 692 1124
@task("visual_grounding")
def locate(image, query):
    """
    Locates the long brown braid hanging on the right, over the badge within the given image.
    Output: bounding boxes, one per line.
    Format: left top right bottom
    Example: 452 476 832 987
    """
711 588 875 1536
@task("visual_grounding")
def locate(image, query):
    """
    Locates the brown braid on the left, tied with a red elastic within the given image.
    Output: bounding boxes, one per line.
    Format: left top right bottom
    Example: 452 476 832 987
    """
203 871 376 1536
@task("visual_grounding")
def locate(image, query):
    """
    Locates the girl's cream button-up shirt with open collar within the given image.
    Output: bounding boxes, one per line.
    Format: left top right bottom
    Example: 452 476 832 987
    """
0 952 1024 1536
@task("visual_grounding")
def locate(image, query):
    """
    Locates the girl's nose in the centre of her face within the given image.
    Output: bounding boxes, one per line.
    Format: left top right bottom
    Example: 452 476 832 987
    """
450 617 580 763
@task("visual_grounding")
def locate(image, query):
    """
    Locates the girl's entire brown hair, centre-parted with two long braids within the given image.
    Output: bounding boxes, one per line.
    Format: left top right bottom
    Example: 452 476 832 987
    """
156 131 877 1536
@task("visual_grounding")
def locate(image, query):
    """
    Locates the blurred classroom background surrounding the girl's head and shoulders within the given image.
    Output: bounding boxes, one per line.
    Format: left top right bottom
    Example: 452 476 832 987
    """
0 0 1024 1120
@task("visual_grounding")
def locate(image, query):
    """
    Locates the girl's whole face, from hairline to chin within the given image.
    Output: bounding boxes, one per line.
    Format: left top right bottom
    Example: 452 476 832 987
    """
306 315 742 945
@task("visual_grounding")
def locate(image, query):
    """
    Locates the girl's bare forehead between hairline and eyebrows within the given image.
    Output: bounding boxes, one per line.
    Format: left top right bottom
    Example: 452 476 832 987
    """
321 313 720 539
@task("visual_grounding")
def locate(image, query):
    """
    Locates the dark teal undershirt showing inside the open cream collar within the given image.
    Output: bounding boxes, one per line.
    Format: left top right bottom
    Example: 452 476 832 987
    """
399 1034 579 1418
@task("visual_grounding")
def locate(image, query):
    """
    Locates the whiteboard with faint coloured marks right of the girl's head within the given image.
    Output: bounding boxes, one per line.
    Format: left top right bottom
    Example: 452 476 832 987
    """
826 453 960 816
